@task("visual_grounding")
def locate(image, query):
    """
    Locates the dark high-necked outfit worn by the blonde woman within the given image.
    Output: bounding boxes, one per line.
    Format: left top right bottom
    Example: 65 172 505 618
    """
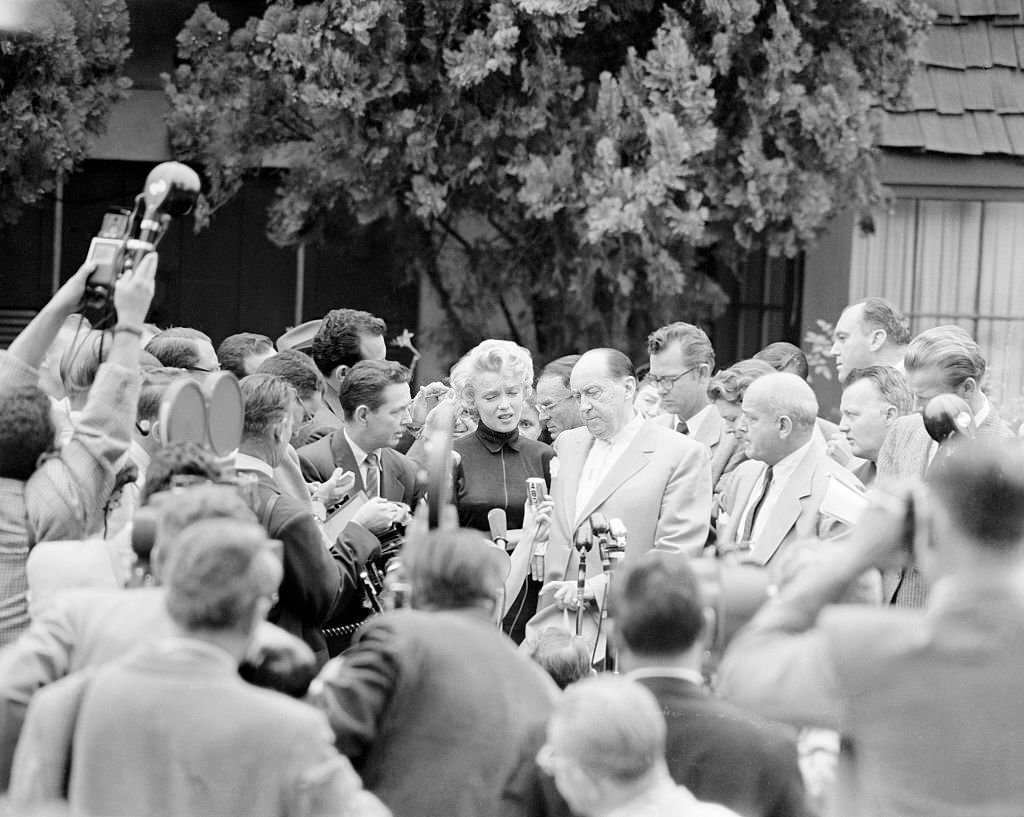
453 423 554 644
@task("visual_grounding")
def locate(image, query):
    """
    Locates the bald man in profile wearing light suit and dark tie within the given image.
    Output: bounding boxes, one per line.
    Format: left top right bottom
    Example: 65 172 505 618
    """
719 373 863 565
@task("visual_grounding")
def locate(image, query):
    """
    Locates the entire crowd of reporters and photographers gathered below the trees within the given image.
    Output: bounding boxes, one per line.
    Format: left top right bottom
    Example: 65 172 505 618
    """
0 254 1024 817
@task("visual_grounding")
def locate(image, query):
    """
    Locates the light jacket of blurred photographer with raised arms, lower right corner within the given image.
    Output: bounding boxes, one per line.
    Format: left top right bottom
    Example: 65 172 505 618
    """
720 567 1024 817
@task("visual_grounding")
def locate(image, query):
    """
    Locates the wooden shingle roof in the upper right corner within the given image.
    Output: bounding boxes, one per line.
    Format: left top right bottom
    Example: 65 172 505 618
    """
879 0 1024 157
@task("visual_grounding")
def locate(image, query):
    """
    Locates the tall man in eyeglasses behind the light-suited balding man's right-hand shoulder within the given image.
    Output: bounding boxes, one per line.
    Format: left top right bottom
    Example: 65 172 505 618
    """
647 320 736 493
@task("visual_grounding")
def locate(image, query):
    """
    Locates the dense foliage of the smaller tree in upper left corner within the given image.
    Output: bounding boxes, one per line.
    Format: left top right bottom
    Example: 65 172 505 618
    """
0 0 130 227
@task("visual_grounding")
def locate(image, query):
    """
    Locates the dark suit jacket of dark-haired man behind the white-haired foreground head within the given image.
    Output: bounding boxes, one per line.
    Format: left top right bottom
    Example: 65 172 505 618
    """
637 675 807 817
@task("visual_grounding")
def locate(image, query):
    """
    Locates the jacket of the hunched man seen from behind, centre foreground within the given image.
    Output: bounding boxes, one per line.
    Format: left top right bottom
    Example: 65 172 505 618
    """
310 609 569 817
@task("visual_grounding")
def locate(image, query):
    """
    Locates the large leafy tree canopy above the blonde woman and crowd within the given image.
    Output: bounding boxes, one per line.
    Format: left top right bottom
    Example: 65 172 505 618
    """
167 0 930 354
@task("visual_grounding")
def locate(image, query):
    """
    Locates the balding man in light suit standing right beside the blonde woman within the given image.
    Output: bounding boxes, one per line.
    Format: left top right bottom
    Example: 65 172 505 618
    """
542 349 712 607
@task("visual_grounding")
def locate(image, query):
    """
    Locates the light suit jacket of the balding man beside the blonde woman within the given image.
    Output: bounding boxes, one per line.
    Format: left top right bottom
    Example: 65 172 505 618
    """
546 421 712 579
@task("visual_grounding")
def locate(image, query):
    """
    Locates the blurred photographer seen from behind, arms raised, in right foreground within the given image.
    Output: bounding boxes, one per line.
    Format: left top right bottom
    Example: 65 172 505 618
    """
719 440 1024 817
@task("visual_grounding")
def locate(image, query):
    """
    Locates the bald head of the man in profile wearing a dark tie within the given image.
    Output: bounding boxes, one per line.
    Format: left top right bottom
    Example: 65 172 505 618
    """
740 372 818 466
